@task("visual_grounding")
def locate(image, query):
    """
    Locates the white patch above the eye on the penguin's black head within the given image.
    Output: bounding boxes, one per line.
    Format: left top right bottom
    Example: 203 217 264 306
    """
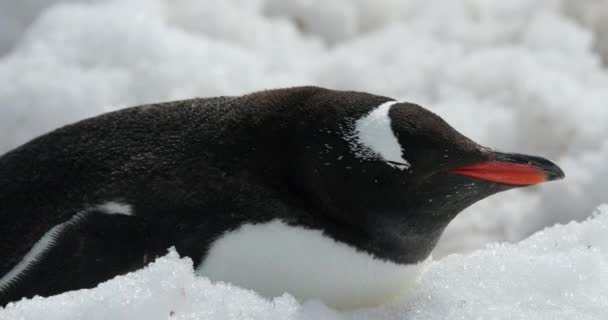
354 101 411 170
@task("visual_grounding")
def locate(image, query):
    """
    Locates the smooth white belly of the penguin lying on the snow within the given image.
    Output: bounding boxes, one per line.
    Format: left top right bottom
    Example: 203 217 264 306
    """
197 220 426 309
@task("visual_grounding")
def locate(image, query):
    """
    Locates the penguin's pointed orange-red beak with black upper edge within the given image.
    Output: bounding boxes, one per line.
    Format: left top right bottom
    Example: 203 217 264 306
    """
450 152 565 186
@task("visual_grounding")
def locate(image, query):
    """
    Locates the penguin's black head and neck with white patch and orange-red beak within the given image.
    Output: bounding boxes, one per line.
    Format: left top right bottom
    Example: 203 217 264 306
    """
290 94 564 263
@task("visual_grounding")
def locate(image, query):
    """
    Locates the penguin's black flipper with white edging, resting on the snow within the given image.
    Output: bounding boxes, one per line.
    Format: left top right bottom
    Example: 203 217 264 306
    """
0 208 157 307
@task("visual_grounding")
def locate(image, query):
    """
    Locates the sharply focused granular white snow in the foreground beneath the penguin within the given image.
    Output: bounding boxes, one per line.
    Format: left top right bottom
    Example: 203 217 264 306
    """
0 205 608 320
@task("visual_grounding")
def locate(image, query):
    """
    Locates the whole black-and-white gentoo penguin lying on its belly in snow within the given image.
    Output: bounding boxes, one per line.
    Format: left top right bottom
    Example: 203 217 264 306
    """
0 87 564 309
